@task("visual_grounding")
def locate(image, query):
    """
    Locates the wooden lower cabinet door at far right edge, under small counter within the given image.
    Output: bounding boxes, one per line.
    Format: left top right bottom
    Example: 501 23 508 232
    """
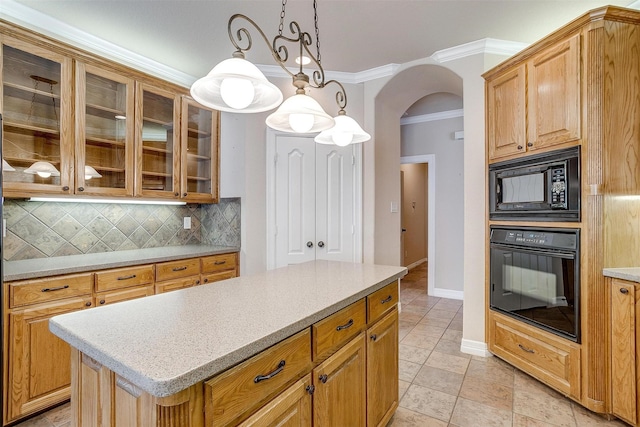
607 279 640 425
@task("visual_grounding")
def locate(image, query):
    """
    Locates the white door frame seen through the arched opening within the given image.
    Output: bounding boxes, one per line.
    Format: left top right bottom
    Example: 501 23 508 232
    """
400 154 436 295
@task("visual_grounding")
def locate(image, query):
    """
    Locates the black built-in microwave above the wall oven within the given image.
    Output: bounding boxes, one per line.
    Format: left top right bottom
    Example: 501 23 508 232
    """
489 147 580 222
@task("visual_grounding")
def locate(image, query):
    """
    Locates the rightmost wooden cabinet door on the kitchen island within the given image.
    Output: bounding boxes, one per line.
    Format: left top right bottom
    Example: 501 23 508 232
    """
367 308 399 427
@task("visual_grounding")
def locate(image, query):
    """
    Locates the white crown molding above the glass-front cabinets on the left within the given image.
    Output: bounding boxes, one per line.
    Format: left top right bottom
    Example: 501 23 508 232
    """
0 0 196 87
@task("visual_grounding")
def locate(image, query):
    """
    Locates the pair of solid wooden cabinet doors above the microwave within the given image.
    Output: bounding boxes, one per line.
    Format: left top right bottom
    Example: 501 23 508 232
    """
487 34 581 161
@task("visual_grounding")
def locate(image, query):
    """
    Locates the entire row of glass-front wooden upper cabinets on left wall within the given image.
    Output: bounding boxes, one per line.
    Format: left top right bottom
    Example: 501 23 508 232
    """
0 24 220 203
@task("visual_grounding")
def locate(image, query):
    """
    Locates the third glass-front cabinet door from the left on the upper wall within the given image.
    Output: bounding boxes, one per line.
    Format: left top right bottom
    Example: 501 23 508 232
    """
136 83 180 198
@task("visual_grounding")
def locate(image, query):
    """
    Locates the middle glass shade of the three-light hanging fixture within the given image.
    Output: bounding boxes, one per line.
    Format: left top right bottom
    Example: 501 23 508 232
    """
266 93 335 133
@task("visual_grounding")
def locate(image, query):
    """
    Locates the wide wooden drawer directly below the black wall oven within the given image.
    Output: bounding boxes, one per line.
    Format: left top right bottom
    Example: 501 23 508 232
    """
490 313 580 398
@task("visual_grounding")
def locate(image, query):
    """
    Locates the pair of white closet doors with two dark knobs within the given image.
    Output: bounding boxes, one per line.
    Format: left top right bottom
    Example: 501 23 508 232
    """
274 135 355 267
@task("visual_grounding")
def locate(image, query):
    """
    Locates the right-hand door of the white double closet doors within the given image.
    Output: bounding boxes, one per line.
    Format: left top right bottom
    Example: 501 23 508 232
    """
316 144 355 261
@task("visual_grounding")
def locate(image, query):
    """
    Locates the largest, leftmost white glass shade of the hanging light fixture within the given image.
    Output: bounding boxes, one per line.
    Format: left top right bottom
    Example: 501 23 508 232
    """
191 58 283 113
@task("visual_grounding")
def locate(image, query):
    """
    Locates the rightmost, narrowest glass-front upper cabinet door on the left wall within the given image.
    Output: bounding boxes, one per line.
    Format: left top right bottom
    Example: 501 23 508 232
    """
180 97 220 203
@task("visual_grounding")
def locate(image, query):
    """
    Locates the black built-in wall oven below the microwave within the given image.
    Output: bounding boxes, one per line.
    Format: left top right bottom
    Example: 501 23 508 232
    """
490 226 580 342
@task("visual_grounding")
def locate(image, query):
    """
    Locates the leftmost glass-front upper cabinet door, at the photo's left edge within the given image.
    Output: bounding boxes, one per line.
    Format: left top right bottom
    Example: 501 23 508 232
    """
0 36 74 197
